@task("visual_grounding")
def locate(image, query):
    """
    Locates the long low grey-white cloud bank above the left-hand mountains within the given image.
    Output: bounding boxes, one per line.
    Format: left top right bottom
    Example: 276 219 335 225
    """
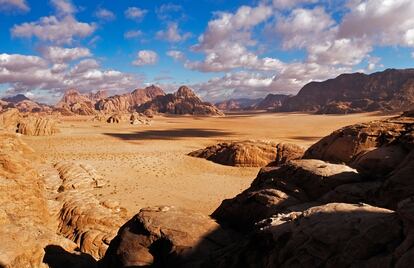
0 53 140 102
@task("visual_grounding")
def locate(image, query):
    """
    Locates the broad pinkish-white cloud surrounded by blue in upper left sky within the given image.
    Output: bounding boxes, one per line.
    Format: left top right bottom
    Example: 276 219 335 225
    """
11 15 96 44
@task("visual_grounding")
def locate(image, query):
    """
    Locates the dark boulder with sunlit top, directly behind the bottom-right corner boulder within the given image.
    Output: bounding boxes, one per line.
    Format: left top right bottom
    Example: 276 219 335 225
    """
212 160 361 231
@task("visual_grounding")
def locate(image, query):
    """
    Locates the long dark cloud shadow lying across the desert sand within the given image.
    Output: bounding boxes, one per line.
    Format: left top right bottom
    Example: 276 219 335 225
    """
104 128 235 140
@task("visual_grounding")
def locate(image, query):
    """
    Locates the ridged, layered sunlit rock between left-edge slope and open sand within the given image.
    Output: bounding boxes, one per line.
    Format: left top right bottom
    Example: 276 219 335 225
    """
55 162 126 259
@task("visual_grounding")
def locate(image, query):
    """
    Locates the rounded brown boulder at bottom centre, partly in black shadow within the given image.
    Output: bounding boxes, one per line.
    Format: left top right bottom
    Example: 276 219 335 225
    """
103 206 237 267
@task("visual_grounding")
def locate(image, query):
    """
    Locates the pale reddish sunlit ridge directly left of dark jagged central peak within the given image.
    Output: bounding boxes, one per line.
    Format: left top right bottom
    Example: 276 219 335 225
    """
95 85 165 112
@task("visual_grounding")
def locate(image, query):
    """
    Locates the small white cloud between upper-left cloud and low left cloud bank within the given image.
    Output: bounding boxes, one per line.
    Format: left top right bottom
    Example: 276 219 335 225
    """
39 46 92 63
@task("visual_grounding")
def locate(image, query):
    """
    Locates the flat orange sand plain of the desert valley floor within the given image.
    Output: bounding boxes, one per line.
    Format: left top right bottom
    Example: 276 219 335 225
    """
24 113 392 215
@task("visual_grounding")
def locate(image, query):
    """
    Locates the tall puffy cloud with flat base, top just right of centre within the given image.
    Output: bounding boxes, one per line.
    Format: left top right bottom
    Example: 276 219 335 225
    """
185 5 279 72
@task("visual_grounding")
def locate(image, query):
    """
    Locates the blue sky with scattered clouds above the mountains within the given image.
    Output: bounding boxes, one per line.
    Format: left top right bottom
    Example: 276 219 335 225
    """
0 0 414 103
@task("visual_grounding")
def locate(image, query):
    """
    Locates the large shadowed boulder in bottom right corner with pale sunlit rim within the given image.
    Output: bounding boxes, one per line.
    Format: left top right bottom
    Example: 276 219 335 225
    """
209 203 413 268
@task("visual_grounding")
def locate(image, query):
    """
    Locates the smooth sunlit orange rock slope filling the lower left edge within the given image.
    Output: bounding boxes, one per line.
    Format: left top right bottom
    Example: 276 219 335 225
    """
0 134 76 268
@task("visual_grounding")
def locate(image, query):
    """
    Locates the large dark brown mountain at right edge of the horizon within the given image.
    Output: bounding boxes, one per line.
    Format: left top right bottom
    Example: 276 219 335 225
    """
278 69 414 114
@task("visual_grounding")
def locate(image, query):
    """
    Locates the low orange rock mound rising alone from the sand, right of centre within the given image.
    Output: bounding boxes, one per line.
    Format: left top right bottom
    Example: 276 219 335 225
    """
188 140 305 167
